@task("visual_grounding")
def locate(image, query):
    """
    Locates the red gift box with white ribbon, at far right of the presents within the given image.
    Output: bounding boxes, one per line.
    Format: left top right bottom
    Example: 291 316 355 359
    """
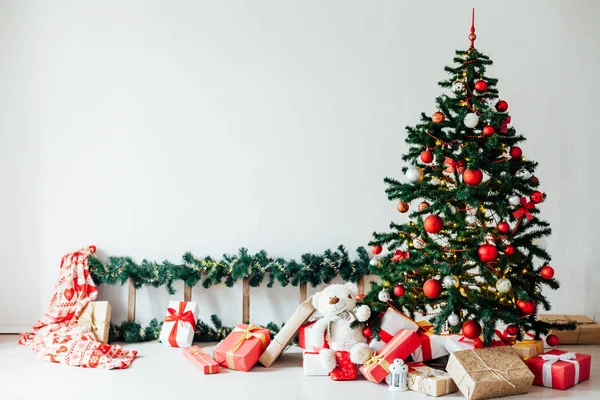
526 350 592 390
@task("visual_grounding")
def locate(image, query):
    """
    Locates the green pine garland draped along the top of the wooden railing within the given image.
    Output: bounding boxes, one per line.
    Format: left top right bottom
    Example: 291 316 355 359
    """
89 246 369 294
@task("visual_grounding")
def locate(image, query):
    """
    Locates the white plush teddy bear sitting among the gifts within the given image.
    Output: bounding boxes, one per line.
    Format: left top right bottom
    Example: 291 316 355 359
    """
311 283 373 380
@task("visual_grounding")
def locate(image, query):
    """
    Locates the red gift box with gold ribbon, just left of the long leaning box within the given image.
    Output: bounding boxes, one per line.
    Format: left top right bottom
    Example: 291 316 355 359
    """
214 324 271 372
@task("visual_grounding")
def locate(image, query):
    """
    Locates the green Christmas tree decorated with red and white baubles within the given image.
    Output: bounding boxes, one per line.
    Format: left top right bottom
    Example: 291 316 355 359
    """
363 10 573 345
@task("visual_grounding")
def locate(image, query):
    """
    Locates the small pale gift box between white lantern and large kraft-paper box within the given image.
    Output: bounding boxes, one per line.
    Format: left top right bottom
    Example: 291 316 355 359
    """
408 363 458 397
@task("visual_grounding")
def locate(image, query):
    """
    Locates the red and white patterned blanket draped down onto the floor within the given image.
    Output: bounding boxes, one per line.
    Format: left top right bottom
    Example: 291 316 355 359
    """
19 246 137 369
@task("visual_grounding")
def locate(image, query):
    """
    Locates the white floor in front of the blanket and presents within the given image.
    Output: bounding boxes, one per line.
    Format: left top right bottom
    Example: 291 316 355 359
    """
0 335 600 400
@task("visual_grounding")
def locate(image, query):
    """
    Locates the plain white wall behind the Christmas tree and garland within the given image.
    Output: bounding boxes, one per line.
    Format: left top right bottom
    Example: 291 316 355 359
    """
0 0 600 331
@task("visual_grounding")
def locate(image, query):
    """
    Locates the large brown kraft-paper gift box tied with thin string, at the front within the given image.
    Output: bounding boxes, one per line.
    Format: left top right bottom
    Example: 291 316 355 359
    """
446 346 534 400
